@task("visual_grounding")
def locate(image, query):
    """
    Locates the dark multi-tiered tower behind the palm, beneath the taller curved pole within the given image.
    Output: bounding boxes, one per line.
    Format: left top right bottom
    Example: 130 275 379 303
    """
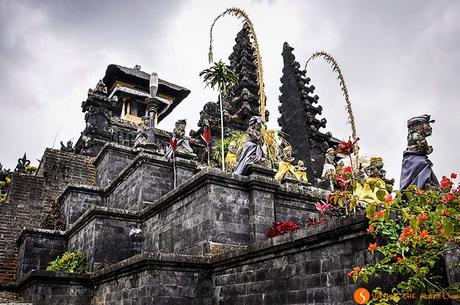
192 23 268 137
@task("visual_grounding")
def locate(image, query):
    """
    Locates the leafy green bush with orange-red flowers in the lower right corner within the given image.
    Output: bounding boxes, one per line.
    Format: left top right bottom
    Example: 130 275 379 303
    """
348 173 460 305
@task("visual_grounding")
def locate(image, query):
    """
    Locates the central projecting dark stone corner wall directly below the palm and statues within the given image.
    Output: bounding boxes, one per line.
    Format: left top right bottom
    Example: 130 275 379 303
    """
143 178 249 254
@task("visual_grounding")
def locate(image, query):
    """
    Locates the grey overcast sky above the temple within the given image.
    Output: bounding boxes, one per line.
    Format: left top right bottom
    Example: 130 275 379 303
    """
0 0 460 184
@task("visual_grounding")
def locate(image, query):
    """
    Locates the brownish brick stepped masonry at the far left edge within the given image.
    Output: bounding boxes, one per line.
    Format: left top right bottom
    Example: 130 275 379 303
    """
0 149 95 283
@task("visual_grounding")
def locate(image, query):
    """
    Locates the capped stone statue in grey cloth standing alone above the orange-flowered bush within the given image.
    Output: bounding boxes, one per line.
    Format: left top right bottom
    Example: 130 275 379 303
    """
400 114 439 190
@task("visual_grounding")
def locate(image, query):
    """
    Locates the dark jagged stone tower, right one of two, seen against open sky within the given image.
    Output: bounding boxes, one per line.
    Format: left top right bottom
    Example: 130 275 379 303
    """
278 42 338 181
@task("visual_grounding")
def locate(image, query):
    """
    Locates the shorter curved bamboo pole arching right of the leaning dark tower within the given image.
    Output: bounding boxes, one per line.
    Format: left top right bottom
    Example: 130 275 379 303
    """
304 51 359 169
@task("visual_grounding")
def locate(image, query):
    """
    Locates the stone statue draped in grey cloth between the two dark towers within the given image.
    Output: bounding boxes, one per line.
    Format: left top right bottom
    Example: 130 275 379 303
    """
233 116 267 175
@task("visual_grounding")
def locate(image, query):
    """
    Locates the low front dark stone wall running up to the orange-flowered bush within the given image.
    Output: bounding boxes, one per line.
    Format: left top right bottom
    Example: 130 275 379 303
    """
213 216 372 305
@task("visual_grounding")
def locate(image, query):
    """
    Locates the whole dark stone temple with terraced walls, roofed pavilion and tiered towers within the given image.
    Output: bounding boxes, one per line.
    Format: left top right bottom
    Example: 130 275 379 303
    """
0 27 459 305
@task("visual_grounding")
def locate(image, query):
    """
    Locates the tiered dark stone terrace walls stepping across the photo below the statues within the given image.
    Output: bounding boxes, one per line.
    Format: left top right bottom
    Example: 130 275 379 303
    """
2 144 459 305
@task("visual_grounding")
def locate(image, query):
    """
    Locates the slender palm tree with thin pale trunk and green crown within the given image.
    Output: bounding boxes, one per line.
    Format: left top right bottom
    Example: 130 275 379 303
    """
200 60 238 171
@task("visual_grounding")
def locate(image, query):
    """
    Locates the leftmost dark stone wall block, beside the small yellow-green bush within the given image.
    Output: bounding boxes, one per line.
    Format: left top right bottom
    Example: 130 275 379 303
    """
16 229 67 279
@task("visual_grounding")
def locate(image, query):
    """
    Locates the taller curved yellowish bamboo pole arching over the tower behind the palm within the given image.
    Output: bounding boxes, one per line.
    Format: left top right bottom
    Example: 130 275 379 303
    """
208 7 265 125
